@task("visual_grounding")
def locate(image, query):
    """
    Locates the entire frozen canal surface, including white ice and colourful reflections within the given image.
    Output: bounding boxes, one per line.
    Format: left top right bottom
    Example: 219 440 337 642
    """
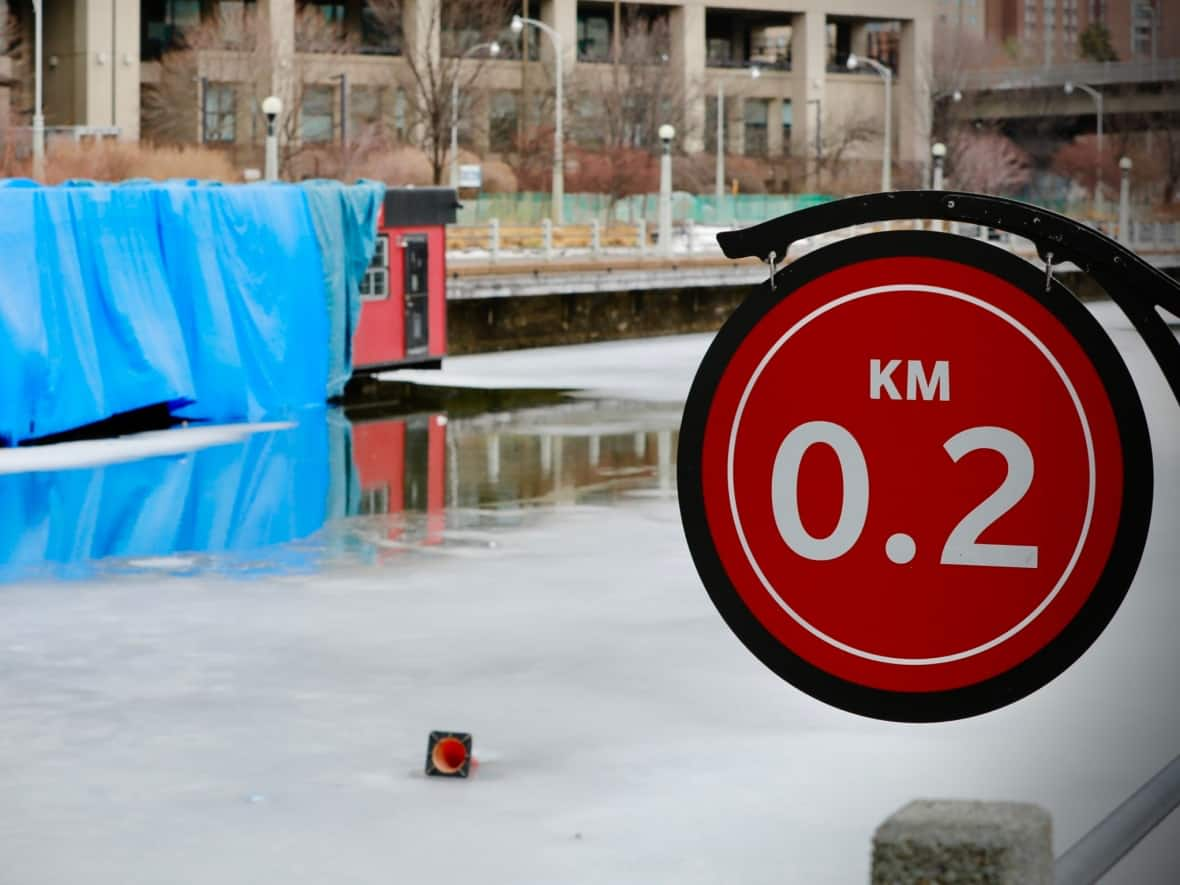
0 306 1180 885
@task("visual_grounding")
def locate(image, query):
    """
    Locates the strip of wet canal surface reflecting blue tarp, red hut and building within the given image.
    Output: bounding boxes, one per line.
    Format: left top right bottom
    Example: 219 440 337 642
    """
0 401 680 581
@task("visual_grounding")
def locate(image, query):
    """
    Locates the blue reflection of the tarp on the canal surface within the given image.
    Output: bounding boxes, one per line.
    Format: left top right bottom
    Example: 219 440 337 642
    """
0 409 332 575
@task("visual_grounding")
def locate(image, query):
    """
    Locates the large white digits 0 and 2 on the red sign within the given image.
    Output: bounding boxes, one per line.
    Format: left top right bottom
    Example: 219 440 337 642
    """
771 421 1037 569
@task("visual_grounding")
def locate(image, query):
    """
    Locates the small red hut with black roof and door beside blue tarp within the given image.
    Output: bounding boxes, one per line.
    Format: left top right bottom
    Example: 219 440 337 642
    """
353 188 459 372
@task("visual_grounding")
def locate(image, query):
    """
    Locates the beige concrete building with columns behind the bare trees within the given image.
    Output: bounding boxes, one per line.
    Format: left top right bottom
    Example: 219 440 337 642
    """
2 0 939 178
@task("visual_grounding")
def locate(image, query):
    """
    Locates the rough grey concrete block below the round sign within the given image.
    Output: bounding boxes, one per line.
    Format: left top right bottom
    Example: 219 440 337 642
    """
871 799 1053 885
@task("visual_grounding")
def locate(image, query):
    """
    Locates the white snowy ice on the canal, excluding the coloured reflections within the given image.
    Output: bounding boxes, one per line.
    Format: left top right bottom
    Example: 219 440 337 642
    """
0 308 1180 885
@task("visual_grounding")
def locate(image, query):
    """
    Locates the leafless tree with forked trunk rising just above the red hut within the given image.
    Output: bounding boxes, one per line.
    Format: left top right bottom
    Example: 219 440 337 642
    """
368 0 512 184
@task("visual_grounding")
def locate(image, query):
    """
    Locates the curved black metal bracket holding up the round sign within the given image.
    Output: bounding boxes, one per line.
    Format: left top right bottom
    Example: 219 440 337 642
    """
717 190 1180 412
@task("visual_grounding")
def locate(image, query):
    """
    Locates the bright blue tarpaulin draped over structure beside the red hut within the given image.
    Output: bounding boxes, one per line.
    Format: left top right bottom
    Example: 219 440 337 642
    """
0 181 384 445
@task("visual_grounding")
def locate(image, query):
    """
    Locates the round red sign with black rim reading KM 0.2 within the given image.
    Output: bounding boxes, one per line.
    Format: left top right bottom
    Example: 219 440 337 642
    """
680 234 1151 720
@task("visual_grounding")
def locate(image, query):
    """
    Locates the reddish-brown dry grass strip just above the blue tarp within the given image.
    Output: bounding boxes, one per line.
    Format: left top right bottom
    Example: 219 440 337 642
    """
0 142 242 184
